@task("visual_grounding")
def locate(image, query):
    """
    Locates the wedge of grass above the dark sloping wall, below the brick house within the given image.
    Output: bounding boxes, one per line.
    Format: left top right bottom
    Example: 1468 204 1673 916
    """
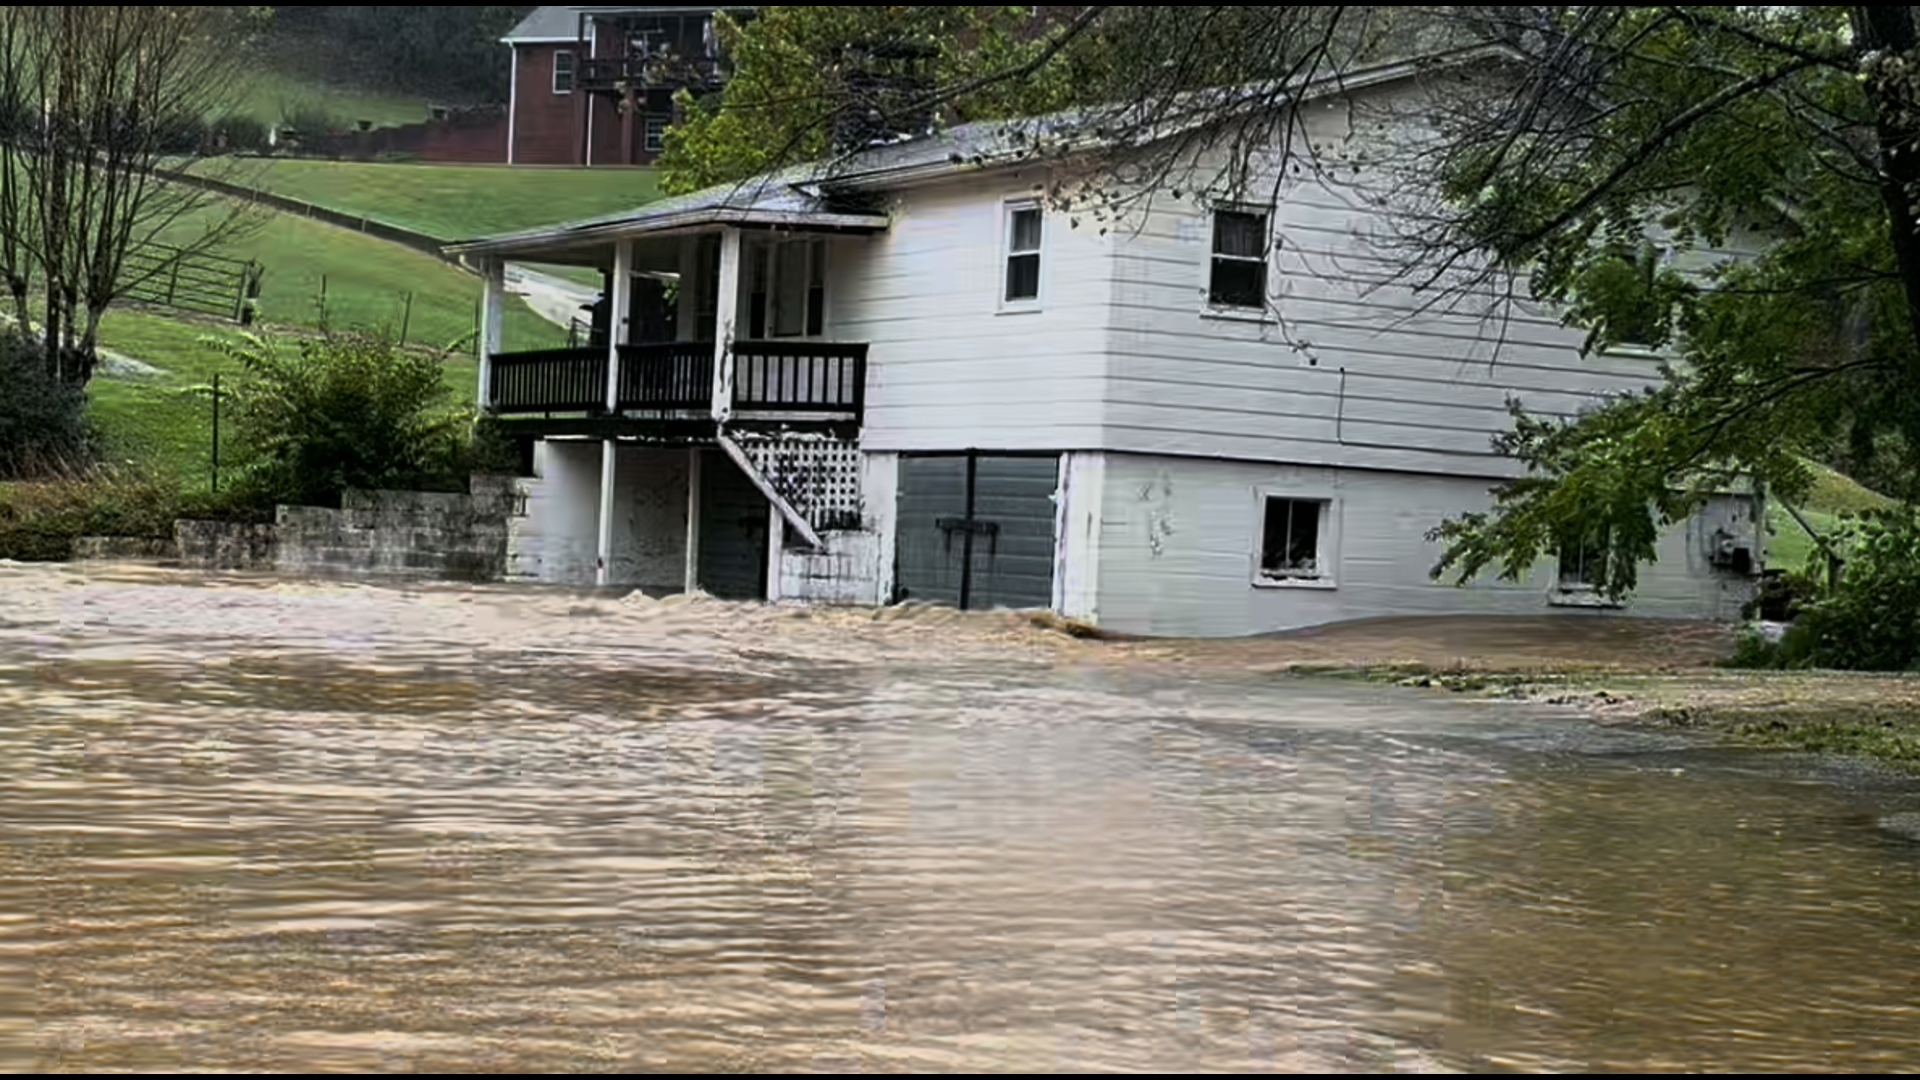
236 160 660 240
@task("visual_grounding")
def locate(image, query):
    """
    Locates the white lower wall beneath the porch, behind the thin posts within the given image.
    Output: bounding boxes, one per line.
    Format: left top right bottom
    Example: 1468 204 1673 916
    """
507 440 687 592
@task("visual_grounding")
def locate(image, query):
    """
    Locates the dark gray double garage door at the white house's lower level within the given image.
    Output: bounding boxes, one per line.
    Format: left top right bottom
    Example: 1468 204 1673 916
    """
895 454 1060 609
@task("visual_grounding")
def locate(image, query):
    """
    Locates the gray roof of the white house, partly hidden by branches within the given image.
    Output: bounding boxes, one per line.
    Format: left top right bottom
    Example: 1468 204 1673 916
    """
445 48 1513 256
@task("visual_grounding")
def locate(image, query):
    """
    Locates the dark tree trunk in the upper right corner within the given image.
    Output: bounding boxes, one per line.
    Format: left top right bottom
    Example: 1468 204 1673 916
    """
1853 6 1920 380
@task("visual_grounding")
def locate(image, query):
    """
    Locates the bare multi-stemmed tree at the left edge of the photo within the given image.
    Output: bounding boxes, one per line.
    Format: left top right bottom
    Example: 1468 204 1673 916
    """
0 6 259 384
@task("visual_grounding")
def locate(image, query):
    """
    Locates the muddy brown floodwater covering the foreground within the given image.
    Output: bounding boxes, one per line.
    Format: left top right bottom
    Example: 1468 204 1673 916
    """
0 565 1920 1072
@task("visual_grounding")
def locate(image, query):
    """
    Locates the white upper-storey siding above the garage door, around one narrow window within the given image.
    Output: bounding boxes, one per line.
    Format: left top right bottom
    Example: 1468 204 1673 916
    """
828 171 1114 452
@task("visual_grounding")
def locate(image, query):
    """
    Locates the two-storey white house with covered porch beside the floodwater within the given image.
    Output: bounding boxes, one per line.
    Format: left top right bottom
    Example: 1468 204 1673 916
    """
449 50 1764 636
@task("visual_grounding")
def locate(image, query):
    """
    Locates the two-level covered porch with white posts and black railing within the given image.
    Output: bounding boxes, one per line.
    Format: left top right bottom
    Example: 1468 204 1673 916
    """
447 186 887 598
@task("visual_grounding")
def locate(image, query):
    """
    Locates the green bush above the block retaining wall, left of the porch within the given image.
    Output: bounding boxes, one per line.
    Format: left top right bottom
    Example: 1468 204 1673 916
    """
225 332 472 507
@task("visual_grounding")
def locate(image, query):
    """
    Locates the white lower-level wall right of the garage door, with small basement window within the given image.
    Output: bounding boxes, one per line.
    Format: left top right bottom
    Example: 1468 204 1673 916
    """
1090 454 1759 636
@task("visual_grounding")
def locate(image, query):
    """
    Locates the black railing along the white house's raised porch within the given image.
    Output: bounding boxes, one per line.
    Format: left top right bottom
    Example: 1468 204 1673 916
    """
488 340 866 423
